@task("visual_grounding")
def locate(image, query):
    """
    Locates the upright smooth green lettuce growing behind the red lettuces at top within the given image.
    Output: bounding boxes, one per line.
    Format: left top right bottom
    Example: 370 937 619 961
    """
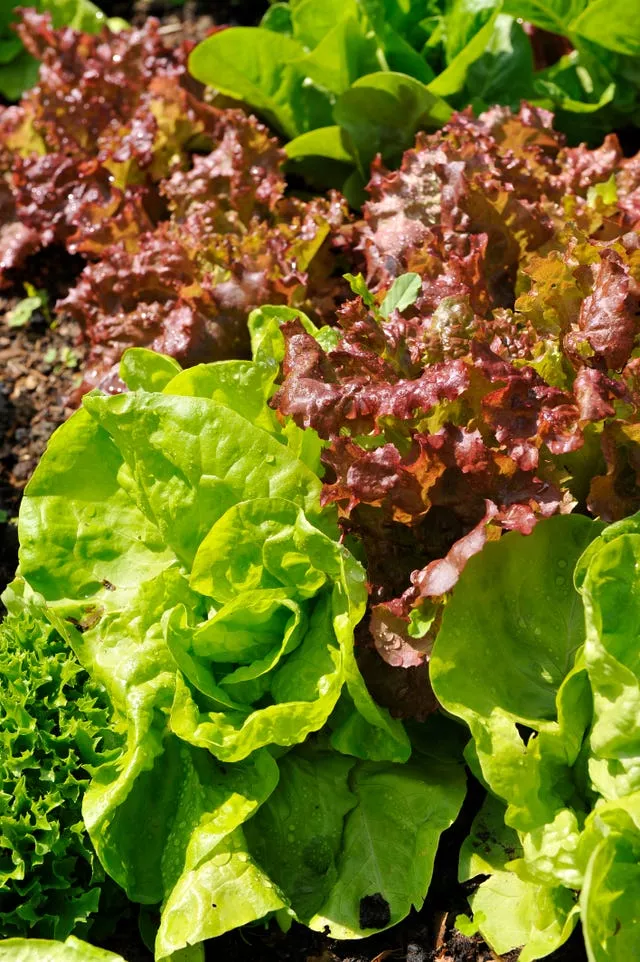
190 0 640 201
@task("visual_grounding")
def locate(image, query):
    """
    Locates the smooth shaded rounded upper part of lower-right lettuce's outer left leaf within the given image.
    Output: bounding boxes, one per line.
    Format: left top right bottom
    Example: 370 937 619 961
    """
431 516 601 727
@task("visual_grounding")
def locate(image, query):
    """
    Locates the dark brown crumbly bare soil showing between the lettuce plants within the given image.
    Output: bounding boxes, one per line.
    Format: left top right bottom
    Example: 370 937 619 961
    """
0 0 592 962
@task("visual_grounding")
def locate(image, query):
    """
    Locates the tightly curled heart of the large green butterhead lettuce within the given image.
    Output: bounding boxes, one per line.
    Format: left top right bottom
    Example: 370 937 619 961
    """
164 498 364 761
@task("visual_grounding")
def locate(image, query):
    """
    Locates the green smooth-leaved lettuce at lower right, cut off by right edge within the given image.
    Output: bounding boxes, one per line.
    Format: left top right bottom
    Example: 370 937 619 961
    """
431 515 640 962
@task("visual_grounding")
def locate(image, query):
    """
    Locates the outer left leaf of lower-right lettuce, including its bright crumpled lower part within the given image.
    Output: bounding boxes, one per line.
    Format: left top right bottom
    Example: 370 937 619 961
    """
431 516 601 887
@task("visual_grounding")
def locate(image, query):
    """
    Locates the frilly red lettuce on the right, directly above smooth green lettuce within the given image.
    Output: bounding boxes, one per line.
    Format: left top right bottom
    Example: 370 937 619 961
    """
271 104 640 676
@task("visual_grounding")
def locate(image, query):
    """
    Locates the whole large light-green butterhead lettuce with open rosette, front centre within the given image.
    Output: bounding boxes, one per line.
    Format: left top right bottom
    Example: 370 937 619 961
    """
6 348 464 959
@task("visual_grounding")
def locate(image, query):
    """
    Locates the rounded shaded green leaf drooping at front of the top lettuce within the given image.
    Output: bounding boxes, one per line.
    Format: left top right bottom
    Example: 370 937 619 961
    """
333 72 451 173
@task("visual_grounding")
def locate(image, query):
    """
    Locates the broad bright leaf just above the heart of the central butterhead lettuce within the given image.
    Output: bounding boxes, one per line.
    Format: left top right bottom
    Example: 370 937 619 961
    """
84 392 328 564
